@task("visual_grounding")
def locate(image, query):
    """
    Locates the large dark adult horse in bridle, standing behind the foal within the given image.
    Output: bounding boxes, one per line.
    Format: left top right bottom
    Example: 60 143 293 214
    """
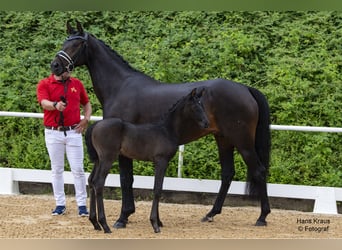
51 22 271 228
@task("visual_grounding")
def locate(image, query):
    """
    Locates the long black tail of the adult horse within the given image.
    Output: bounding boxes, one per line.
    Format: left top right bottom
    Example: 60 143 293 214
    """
247 87 271 196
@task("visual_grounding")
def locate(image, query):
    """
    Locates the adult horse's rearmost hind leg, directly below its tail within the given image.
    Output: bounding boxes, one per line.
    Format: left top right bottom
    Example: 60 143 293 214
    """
239 147 271 226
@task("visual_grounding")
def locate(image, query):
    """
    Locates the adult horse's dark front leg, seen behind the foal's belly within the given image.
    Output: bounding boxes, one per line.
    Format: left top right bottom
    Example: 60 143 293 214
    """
114 156 135 228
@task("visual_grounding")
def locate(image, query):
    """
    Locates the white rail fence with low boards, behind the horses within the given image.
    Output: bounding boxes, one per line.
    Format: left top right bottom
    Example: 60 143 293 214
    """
0 111 342 214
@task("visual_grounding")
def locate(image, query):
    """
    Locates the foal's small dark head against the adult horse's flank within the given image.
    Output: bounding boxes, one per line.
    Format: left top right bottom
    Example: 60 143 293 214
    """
184 88 209 128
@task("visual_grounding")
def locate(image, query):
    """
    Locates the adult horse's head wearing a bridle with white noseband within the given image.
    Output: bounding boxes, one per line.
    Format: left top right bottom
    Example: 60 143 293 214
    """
51 21 88 75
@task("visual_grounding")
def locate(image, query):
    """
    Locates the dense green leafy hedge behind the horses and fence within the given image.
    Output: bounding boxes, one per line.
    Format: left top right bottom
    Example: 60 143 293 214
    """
0 11 342 187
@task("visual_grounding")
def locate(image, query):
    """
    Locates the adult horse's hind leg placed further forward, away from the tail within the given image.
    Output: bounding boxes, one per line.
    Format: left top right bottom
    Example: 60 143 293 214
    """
202 136 235 222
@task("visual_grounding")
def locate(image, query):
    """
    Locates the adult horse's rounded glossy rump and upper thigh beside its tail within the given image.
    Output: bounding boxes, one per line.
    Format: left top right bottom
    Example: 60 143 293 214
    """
200 79 259 138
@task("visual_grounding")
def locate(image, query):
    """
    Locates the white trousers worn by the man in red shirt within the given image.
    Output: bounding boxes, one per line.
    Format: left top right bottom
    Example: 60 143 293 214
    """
44 129 87 206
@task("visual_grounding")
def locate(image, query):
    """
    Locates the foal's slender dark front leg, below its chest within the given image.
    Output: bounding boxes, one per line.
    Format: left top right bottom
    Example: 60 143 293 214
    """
150 159 168 233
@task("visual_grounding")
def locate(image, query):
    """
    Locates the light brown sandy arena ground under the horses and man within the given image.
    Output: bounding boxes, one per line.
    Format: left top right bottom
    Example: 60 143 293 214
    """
0 195 342 239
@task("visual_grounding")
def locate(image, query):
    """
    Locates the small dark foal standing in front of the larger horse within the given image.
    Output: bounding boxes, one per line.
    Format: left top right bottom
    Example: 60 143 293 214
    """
86 88 209 233
